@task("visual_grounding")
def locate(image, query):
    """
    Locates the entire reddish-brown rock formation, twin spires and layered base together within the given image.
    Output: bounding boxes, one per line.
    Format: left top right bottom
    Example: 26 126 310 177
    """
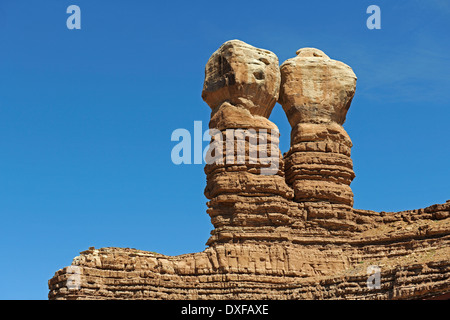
49 40 450 299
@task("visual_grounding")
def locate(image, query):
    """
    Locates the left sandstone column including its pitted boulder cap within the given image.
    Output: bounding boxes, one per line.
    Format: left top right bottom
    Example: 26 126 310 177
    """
202 40 293 245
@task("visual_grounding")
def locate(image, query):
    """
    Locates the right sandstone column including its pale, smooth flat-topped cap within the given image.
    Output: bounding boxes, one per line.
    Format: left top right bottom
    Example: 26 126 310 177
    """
279 48 356 208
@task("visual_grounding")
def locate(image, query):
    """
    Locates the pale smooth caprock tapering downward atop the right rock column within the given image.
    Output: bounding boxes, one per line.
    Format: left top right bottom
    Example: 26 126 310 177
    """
279 48 356 127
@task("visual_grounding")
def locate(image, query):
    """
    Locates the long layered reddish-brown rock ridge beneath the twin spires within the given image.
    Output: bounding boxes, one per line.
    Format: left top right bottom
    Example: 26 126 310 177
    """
49 202 450 299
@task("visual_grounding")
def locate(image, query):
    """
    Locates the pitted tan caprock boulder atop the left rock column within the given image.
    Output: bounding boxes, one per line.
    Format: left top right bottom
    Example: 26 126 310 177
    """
202 40 280 118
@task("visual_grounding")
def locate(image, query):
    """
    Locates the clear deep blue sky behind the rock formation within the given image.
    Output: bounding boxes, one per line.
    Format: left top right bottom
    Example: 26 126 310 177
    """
0 0 450 299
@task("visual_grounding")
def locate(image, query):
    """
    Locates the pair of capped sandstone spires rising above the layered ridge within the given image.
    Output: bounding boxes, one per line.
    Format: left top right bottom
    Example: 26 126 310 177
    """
202 40 356 244
